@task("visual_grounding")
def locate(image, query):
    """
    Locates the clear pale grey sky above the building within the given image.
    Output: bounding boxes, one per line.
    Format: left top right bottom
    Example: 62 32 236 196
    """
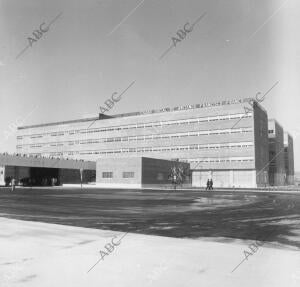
0 0 300 171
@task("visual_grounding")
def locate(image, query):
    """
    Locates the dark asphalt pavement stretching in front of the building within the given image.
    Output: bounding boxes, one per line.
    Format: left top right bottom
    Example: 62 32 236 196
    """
0 188 300 248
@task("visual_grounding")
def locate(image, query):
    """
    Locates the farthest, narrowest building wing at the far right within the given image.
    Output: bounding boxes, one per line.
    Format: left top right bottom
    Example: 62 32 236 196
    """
284 132 295 185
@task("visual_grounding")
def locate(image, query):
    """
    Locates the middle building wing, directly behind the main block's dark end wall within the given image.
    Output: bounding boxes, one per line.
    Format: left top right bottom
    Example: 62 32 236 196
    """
268 119 286 185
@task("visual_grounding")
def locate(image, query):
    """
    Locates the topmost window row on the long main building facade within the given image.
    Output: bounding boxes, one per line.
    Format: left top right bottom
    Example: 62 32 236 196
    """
17 113 252 139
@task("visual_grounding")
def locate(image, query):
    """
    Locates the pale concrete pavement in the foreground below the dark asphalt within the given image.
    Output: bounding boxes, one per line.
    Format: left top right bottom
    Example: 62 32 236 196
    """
0 218 300 287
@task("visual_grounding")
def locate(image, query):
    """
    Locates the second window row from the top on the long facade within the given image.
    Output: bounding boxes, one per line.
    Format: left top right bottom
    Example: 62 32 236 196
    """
17 128 253 148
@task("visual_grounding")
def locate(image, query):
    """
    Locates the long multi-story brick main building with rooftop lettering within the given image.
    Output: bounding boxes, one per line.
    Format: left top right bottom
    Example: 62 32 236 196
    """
17 99 269 187
